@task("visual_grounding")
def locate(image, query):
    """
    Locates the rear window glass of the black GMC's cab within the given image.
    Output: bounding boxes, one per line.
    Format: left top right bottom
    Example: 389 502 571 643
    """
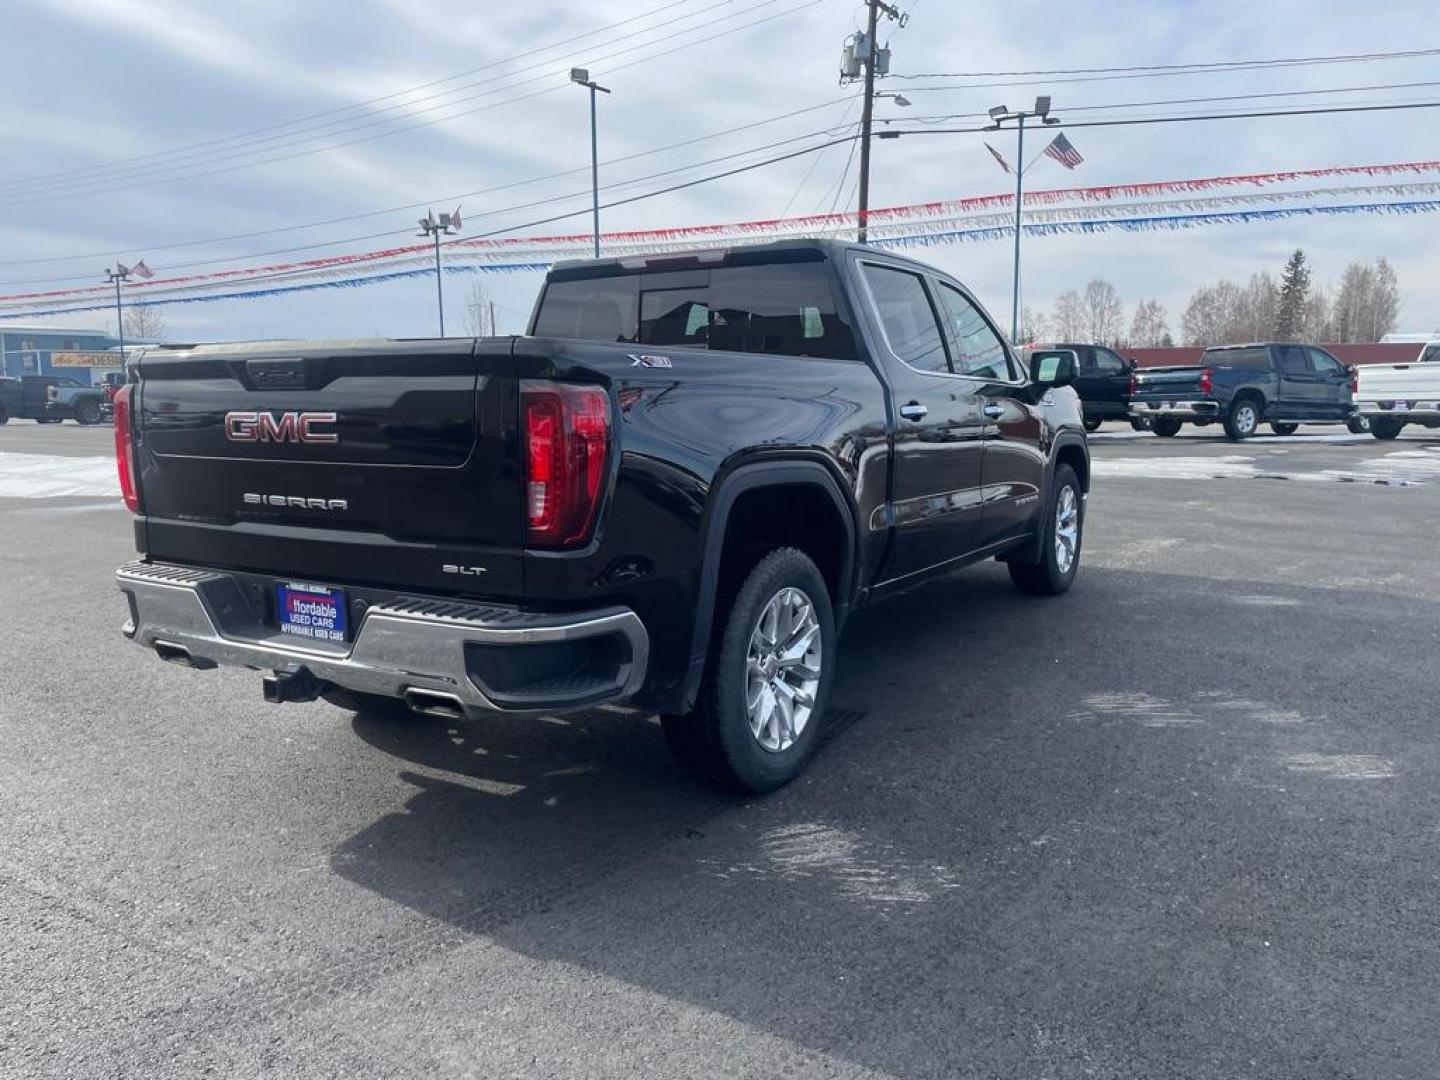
534 262 855 360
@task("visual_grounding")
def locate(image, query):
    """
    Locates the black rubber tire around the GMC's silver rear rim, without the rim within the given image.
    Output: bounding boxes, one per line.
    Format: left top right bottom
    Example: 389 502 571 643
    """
661 547 837 795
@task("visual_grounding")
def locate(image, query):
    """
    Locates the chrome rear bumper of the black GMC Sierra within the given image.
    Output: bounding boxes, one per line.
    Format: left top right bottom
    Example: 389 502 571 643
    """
115 562 649 714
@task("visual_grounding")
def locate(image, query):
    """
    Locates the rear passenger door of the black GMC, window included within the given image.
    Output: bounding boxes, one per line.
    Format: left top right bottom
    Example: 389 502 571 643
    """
855 256 985 580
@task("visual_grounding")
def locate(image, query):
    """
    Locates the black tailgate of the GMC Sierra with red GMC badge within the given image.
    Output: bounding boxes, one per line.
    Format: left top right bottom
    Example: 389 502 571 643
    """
137 338 524 595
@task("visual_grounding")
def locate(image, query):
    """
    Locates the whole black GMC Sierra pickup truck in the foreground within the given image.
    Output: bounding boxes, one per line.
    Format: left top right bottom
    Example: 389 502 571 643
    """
115 240 1090 792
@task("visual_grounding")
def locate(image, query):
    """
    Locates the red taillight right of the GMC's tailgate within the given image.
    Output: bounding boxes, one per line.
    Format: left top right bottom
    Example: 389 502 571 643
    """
520 380 611 547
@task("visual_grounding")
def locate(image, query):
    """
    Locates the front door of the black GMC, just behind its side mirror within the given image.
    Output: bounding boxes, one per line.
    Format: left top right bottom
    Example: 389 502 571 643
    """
937 281 1047 549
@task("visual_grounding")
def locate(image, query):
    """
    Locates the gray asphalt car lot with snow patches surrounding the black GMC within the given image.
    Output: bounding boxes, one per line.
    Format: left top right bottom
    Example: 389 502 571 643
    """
0 422 1440 1080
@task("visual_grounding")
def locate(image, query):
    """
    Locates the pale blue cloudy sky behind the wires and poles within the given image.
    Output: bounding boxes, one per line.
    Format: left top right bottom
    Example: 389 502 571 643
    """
0 0 1440 340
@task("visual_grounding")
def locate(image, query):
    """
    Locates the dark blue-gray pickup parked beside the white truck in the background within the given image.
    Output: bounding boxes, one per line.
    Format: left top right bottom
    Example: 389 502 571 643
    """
1130 341 1365 441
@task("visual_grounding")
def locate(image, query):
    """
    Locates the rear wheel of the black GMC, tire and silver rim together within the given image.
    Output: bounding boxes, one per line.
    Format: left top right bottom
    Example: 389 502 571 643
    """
661 547 835 793
